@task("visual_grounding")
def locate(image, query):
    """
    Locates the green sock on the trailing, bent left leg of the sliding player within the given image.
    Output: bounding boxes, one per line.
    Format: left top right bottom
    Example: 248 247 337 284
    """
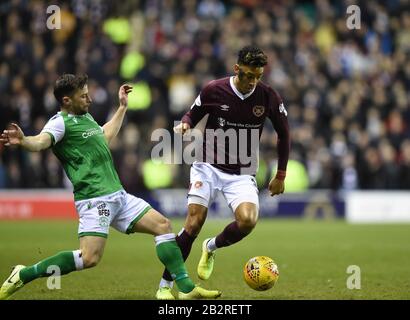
20 251 76 284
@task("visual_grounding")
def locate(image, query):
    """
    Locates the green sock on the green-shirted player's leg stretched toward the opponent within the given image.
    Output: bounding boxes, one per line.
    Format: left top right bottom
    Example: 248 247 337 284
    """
156 238 195 293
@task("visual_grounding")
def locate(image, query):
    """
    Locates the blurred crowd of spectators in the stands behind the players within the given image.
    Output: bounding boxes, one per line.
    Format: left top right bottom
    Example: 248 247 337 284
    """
0 0 410 193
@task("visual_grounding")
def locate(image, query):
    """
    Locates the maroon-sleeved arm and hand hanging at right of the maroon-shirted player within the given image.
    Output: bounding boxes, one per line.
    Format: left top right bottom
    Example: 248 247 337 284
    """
268 98 290 196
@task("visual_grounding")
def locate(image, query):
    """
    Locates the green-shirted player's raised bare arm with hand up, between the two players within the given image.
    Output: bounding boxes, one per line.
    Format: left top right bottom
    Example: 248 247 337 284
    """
103 84 132 144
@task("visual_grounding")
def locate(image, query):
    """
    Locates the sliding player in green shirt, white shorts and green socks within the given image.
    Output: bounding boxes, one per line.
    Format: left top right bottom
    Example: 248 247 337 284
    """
0 74 221 300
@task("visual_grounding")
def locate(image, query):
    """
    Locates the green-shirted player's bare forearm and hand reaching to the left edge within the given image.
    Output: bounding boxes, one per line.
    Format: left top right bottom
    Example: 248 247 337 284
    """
0 123 52 152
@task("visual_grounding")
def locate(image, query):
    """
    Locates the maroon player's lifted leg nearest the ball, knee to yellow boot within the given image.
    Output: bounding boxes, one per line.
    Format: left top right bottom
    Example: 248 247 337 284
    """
197 202 258 280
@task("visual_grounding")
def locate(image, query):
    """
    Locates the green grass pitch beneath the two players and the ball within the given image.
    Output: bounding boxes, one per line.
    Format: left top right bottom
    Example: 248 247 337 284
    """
0 219 410 300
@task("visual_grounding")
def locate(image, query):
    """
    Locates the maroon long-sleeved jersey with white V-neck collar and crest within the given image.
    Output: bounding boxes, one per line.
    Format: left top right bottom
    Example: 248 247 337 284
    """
182 77 290 175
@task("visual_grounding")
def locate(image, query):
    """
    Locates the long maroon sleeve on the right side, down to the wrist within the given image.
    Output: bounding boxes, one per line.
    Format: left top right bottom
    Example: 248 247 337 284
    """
268 90 290 171
